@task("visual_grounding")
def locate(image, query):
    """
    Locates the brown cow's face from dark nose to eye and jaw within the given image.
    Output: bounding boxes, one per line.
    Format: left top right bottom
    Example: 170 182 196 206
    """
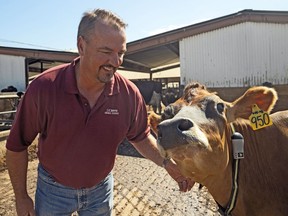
158 96 227 181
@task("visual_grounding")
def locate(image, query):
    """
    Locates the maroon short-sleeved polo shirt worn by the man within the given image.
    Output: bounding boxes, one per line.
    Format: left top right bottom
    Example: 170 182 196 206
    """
6 59 149 188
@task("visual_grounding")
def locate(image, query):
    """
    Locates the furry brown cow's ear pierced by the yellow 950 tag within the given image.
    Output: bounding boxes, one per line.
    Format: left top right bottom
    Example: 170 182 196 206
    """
227 86 278 122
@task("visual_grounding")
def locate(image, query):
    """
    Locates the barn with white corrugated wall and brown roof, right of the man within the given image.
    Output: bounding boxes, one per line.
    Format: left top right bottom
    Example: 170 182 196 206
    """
127 10 288 111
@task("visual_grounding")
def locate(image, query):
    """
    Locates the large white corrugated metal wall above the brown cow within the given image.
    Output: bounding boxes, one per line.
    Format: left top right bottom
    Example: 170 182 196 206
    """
180 22 288 87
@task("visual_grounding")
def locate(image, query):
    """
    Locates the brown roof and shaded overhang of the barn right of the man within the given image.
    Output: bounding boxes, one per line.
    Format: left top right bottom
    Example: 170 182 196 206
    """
124 10 288 73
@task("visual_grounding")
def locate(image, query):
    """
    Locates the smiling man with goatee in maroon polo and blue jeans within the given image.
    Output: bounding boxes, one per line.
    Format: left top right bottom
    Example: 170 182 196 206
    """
6 9 193 216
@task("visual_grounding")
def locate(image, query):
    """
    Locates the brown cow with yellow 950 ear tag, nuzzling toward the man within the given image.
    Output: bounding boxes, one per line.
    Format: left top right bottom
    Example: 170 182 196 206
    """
150 83 288 216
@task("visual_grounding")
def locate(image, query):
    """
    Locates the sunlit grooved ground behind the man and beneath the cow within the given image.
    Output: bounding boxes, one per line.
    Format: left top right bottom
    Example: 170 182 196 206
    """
0 138 219 216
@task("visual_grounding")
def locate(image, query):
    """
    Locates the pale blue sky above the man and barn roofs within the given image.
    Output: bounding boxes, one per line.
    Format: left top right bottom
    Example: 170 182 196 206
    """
0 0 288 50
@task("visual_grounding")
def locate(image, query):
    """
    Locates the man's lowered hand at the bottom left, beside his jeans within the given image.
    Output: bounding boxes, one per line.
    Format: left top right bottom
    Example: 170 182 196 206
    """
16 195 36 216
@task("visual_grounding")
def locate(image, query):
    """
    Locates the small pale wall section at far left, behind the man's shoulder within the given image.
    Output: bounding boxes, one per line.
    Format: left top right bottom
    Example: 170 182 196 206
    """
0 55 26 91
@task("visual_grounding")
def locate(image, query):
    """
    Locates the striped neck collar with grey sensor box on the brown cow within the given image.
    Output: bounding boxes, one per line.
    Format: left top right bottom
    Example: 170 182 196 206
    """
217 123 244 216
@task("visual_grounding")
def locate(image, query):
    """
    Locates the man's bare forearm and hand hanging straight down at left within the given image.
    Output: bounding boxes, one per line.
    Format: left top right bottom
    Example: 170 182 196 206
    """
6 149 35 216
